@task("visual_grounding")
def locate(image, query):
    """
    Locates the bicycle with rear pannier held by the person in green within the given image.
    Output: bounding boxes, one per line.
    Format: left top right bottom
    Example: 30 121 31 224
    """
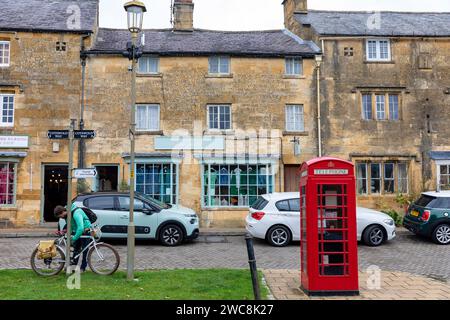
30 229 120 277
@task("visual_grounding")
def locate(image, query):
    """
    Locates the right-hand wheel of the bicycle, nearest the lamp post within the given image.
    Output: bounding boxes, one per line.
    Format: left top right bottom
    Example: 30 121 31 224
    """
88 243 120 276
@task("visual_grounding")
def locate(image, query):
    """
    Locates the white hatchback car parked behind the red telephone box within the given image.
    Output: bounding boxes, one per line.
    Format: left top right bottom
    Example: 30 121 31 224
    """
245 192 395 247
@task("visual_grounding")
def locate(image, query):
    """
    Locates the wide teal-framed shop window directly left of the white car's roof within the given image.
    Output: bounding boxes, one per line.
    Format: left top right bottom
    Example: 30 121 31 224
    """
203 165 273 207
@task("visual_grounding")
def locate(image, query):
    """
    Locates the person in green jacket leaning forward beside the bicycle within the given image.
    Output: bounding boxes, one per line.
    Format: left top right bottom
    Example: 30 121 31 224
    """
54 204 91 272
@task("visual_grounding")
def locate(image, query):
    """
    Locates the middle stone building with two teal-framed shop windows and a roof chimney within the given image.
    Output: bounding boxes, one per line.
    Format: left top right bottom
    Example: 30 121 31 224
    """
84 1 320 227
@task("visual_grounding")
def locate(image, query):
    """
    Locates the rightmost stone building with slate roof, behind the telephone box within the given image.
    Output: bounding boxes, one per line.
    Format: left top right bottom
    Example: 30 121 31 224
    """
283 0 450 207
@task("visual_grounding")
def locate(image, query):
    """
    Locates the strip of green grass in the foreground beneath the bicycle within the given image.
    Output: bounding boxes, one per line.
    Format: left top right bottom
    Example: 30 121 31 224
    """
0 269 268 300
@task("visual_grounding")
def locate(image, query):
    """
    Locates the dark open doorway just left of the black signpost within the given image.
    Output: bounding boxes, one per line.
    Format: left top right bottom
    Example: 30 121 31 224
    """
43 165 69 222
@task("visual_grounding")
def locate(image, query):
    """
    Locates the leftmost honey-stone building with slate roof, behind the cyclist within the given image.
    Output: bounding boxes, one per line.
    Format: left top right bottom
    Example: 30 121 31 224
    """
0 0 98 227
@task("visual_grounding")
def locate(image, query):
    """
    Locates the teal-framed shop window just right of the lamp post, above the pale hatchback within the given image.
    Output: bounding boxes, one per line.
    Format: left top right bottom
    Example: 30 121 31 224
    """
136 163 178 204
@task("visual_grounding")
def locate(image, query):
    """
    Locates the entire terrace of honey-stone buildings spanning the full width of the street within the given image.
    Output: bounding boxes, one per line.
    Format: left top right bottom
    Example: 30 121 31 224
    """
0 0 450 227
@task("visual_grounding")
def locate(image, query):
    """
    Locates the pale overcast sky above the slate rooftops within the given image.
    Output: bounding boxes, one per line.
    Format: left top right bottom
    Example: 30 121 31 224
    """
100 0 450 30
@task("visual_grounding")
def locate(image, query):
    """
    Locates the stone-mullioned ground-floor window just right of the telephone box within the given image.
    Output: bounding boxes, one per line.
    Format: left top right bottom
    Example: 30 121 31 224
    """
356 161 408 195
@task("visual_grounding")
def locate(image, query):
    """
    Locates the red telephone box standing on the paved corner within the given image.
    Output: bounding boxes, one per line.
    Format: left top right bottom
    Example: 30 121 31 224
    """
300 157 359 295
